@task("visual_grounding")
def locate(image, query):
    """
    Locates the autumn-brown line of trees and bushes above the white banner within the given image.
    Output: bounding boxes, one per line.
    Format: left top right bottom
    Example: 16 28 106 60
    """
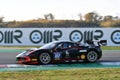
0 12 120 28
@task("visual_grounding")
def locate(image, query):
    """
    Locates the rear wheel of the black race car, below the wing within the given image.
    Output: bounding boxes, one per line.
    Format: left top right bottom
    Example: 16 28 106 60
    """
86 51 98 63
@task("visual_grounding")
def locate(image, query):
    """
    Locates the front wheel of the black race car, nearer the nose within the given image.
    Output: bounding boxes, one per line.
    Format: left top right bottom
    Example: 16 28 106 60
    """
39 52 51 64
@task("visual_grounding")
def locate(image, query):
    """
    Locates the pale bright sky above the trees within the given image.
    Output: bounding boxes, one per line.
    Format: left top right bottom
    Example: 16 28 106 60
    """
0 0 120 21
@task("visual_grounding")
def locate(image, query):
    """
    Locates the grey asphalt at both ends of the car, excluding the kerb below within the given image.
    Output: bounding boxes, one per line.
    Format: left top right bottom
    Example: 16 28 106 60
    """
0 49 120 64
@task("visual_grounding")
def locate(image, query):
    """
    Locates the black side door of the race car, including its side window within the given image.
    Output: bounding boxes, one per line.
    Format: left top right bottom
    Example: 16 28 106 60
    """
54 42 79 61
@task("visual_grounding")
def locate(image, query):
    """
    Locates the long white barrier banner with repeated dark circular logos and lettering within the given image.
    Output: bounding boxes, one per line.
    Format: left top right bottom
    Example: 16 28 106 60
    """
0 28 120 46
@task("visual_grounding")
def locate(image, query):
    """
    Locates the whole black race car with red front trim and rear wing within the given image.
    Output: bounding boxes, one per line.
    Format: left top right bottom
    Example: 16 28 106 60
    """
16 40 107 64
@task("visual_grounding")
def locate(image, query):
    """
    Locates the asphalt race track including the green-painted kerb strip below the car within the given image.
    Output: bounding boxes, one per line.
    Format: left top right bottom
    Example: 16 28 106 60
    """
0 49 120 72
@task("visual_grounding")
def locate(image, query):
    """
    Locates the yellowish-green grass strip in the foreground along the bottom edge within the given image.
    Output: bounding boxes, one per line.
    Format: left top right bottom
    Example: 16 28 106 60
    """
0 68 120 80
